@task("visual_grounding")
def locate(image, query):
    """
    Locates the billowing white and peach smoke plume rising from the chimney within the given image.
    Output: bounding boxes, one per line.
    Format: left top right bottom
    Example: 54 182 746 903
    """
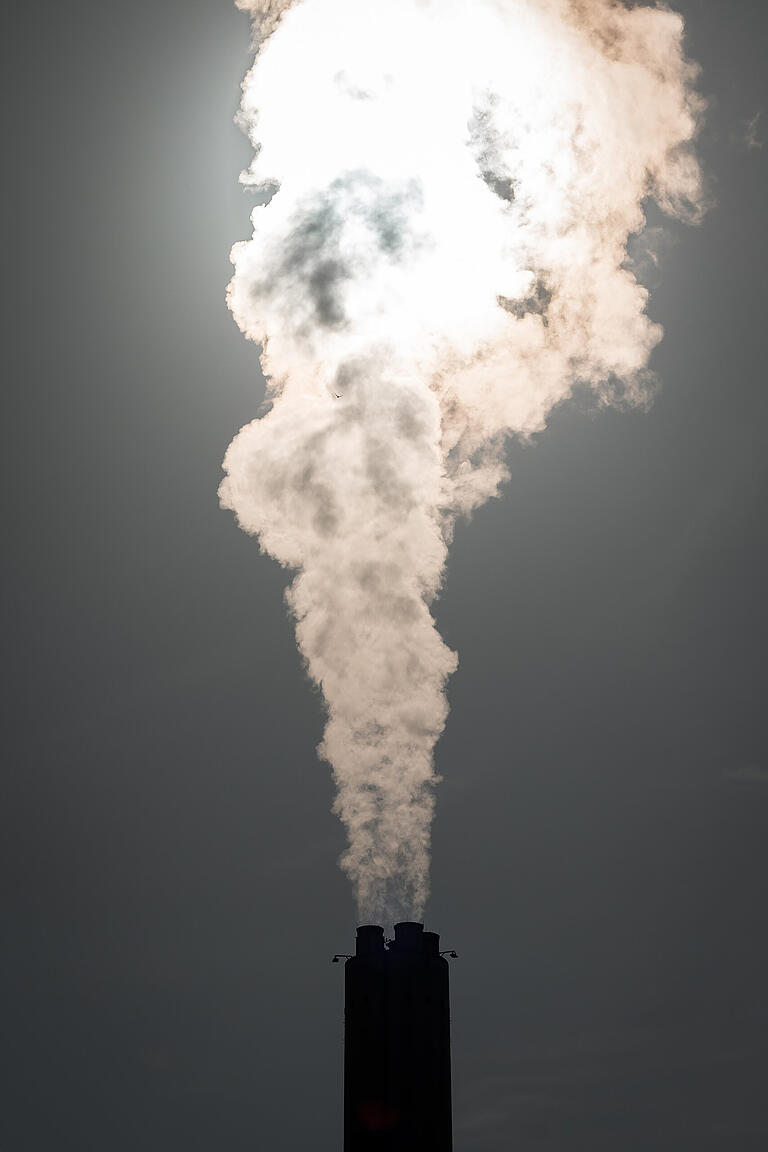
221 0 701 922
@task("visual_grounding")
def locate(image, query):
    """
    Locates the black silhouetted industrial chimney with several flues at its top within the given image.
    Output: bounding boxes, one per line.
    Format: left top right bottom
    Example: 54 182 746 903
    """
344 922 455 1152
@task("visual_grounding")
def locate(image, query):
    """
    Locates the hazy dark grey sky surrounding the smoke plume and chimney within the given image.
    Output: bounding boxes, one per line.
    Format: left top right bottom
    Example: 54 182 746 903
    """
6 0 768 1152
